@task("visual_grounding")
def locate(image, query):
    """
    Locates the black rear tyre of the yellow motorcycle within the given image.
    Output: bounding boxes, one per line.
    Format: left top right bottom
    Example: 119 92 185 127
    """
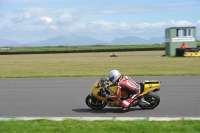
138 91 160 109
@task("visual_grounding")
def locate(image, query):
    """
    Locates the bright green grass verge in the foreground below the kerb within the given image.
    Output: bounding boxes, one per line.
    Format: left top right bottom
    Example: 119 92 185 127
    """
0 120 200 133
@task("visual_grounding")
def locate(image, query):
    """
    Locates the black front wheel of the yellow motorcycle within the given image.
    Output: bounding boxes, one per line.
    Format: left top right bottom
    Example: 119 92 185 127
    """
85 95 107 109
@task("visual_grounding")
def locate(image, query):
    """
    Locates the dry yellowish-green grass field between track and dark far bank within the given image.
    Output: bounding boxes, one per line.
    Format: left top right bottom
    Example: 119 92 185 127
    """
0 51 200 78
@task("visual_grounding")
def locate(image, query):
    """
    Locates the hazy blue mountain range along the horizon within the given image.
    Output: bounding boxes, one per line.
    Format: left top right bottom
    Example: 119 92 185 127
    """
0 35 200 47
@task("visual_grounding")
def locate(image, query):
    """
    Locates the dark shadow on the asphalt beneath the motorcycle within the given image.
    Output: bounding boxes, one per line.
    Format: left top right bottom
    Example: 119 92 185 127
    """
72 108 143 113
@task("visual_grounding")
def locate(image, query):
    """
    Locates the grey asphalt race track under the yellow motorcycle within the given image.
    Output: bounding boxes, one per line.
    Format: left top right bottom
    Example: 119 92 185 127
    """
0 76 200 117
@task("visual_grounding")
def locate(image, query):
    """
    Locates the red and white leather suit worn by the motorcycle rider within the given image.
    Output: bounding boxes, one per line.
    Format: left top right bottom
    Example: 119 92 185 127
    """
110 75 140 108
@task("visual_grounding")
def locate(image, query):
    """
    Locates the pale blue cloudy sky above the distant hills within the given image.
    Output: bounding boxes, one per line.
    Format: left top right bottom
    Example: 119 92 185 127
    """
0 0 200 43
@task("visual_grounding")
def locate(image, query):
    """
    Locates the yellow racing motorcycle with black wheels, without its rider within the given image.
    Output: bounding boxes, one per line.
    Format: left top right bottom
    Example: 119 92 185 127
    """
85 78 161 109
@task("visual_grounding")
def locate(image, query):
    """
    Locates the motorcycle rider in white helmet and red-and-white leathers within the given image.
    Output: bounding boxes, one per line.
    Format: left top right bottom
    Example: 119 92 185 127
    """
108 70 140 110
